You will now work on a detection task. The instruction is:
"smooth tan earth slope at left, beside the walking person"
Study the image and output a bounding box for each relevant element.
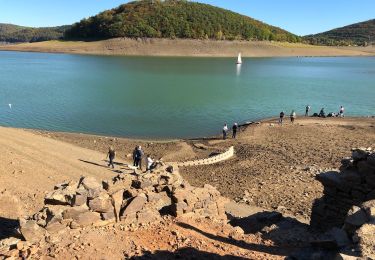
[0,127,129,217]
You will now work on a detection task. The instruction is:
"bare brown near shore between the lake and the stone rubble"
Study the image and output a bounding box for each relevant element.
[0,117,375,220]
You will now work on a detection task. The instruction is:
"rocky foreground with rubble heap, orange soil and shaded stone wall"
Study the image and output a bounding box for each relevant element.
[0,148,375,259]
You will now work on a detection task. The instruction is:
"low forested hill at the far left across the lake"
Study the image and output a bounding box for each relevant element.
[0,23,70,43]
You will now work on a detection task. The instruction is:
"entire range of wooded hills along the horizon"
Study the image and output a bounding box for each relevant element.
[0,0,375,46]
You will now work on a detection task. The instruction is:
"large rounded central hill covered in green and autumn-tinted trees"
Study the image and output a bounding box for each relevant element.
[65,0,300,42]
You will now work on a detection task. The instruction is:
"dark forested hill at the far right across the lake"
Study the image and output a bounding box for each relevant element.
[304,19,375,46]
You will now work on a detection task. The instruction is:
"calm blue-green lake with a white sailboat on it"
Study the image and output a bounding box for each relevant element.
[0,51,375,138]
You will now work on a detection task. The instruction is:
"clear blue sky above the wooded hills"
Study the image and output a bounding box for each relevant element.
[0,0,375,35]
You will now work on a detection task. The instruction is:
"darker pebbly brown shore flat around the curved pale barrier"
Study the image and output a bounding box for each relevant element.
[26,117,375,221]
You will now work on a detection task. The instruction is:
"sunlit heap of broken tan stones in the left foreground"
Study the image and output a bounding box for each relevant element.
[16,167,228,246]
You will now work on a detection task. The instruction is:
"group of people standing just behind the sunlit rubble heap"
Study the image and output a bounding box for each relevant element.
[107,145,161,171]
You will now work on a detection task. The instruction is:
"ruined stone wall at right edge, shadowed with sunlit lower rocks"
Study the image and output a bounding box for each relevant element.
[311,148,375,257]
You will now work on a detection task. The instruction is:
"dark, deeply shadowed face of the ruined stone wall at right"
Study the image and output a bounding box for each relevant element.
[311,149,375,229]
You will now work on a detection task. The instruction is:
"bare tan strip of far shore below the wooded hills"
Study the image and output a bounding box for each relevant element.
[0,38,375,57]
